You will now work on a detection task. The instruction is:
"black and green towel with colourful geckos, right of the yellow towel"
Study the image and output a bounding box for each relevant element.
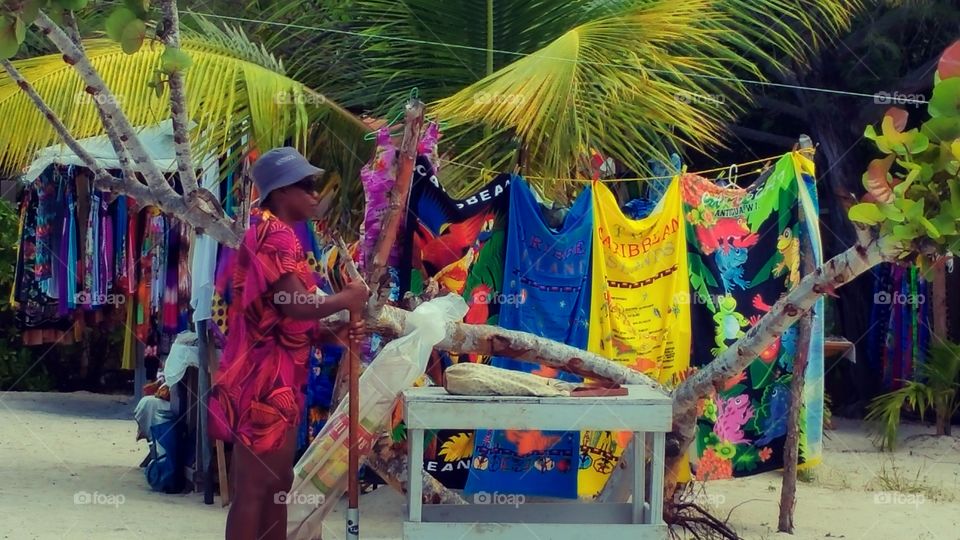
[681,155,807,480]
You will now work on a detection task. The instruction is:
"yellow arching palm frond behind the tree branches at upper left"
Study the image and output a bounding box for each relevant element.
[0,20,366,197]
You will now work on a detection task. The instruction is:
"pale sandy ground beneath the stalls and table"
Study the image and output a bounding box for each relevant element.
[0,392,960,540]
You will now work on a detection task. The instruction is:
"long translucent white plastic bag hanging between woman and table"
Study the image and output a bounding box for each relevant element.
[286,295,467,538]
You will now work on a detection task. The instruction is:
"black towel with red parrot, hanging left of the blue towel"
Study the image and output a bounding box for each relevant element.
[394,159,513,489]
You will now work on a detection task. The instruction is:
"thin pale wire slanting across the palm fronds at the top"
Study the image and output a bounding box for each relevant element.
[183,9,928,105]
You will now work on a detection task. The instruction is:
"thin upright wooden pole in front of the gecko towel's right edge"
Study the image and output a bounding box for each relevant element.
[777,135,818,534]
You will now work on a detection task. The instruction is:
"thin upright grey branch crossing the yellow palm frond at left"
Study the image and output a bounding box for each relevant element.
[163,0,198,195]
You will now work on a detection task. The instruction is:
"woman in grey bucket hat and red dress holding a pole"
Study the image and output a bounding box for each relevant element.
[210,148,368,540]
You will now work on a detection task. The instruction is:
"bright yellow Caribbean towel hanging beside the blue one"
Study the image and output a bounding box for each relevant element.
[578,181,690,499]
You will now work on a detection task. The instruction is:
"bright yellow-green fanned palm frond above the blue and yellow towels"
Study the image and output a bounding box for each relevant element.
[436,0,748,186]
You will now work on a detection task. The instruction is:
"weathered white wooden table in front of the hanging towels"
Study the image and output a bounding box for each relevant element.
[403,386,672,540]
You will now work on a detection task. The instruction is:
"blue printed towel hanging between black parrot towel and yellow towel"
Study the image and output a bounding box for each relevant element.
[466,177,593,499]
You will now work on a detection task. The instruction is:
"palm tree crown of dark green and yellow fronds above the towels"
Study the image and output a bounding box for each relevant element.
[249,0,861,198]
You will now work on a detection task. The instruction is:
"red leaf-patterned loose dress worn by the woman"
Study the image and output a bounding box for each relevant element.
[210,211,319,453]
